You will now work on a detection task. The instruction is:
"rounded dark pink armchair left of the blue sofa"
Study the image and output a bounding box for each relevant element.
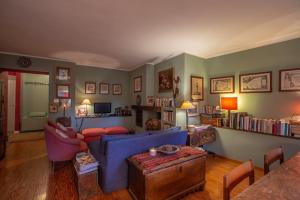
[45,125,88,164]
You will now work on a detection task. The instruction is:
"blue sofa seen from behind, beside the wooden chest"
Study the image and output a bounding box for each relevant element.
[89,130,187,193]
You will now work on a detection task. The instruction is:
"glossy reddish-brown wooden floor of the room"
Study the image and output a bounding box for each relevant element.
[0,133,263,200]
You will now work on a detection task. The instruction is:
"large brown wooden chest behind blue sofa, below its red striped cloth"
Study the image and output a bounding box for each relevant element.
[129,147,206,200]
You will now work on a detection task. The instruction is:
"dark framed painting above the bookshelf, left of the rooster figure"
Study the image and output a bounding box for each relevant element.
[158,68,173,92]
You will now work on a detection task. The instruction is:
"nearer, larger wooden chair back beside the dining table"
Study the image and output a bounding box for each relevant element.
[223,160,254,200]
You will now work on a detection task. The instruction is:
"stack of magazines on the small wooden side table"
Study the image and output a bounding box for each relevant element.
[75,152,99,174]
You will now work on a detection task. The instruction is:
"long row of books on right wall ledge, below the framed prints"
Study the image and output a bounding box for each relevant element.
[229,112,292,136]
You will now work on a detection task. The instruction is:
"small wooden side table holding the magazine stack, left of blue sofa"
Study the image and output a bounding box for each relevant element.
[74,163,99,200]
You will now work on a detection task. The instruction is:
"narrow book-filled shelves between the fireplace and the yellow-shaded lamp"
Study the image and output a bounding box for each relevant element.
[161,107,176,130]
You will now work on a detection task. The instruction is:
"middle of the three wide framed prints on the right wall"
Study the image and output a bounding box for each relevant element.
[239,72,272,93]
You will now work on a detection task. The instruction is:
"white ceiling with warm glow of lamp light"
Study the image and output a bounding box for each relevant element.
[0,0,300,70]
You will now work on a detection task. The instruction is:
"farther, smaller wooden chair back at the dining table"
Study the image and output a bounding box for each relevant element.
[264,147,284,175]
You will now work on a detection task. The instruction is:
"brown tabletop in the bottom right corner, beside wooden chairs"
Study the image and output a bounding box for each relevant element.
[233,152,300,200]
